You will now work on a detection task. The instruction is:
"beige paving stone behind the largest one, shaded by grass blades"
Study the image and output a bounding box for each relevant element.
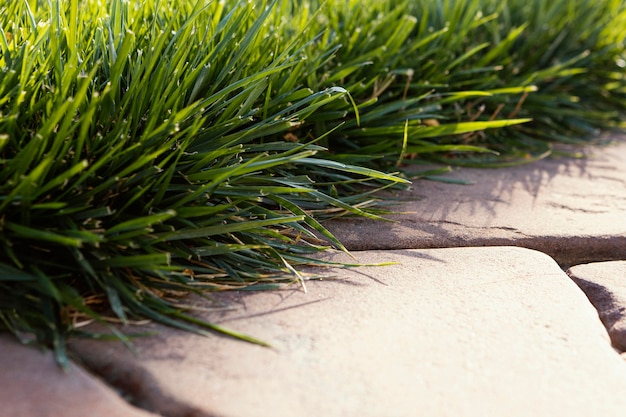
[325,139,626,266]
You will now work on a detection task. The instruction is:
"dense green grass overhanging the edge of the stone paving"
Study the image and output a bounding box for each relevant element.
[0,0,626,362]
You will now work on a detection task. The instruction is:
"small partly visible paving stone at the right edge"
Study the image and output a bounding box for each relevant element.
[567,261,626,351]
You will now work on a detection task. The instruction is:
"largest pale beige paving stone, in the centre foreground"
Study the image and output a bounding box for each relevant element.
[71,247,626,417]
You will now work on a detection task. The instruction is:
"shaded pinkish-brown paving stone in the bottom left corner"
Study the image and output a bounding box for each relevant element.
[0,334,156,417]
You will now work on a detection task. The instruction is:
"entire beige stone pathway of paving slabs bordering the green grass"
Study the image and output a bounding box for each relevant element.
[0,136,626,417]
